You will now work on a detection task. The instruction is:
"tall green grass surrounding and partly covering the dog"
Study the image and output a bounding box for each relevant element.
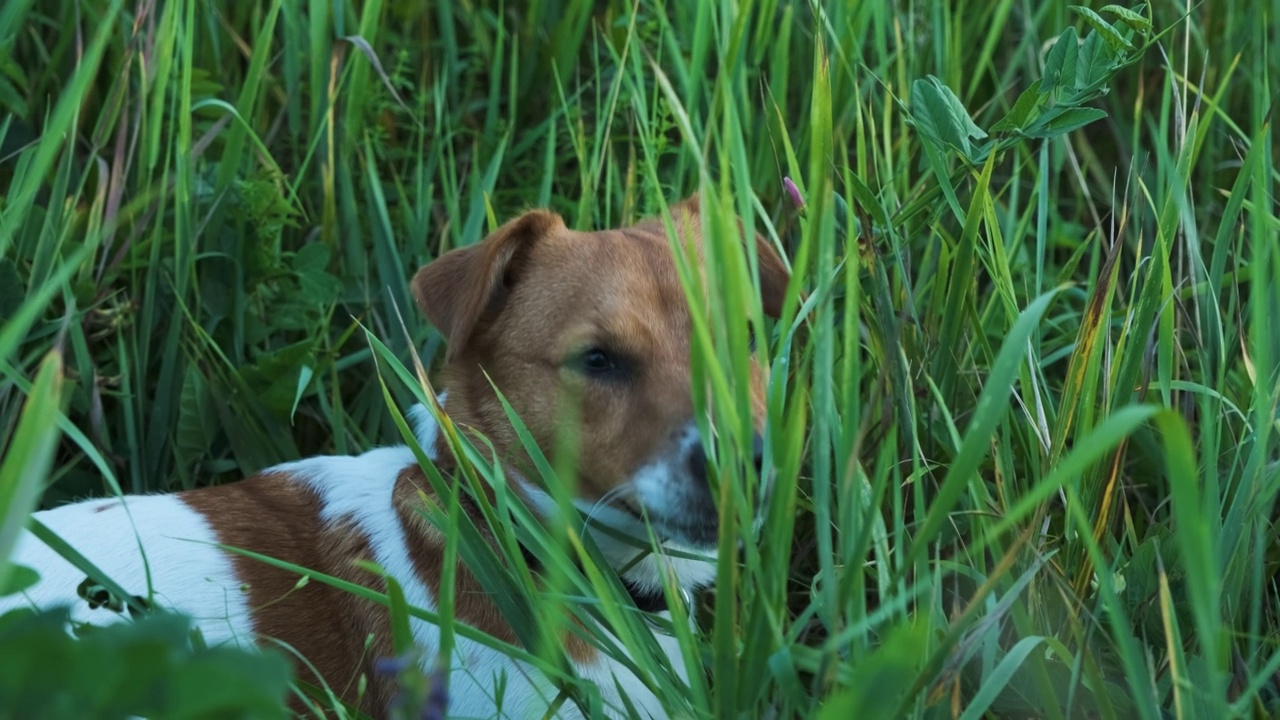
[0,0,1280,719]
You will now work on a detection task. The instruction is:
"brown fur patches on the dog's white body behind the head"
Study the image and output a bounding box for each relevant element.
[180,466,595,716]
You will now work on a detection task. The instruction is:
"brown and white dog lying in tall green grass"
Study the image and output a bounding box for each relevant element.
[0,196,790,717]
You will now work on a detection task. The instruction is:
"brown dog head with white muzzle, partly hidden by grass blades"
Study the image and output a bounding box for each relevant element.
[412,197,788,589]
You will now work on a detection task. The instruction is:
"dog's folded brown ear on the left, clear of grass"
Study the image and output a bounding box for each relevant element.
[411,210,564,360]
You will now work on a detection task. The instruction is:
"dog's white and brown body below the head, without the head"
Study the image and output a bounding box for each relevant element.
[0,407,682,717]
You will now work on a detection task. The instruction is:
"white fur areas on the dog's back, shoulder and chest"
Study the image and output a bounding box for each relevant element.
[0,396,691,719]
